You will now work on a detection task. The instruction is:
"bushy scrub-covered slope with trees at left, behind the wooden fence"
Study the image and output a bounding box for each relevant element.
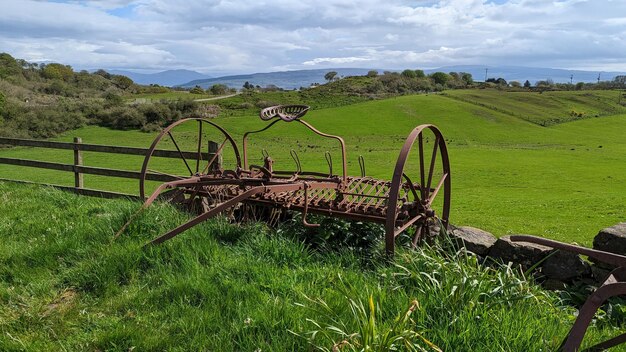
[0,53,205,138]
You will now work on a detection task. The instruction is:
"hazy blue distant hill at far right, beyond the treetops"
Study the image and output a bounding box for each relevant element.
[424,65,626,85]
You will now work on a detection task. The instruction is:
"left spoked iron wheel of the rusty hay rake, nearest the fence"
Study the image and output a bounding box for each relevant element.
[139,118,241,214]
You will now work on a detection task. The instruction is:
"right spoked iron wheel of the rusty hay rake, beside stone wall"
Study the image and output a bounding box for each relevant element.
[385,125,450,255]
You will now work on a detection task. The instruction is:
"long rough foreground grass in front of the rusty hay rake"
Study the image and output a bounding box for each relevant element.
[0,182,618,351]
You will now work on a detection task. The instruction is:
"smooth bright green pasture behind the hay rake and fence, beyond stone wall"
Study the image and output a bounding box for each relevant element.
[0,90,626,245]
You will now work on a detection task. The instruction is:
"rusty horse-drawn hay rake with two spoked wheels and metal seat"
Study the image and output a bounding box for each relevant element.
[124,105,450,254]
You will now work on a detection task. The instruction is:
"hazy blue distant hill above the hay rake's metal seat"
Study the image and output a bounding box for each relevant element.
[180,68,382,89]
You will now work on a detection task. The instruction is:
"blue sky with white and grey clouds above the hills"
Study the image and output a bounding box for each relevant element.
[0,0,626,75]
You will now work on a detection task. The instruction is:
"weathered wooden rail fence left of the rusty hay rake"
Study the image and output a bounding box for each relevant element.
[0,137,211,199]
